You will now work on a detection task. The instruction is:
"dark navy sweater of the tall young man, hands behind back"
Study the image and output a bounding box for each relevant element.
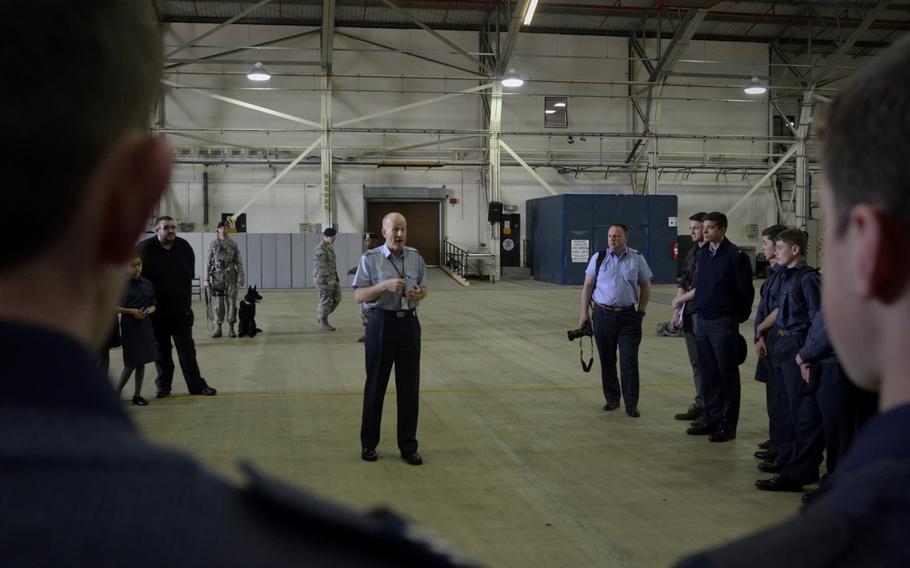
[694,239,755,323]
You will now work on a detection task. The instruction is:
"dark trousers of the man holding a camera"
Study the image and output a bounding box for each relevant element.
[594,306,642,409]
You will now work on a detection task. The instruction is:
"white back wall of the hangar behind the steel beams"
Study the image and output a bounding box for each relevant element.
[160,25,796,255]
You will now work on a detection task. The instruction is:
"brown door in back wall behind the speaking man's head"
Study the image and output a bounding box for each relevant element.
[364,200,442,266]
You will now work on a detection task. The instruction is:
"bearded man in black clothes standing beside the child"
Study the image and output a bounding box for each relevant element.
[142,215,218,398]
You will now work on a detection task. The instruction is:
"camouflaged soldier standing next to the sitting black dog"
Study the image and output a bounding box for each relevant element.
[205,223,244,338]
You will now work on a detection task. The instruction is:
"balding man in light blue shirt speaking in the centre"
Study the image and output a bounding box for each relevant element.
[354,213,427,465]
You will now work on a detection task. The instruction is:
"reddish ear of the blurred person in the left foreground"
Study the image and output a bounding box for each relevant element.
[100,136,171,263]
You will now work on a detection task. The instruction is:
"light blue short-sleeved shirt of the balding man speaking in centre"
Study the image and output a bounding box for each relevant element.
[354,245,427,311]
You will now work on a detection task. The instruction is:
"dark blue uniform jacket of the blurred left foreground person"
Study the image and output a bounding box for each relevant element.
[0,321,478,568]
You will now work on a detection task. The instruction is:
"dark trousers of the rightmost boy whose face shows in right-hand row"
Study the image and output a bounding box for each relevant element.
[774,333,825,484]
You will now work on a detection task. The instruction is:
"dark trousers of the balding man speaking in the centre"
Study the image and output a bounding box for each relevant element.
[360,310,420,453]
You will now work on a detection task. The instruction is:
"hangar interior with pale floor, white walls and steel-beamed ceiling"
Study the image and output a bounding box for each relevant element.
[112,0,910,566]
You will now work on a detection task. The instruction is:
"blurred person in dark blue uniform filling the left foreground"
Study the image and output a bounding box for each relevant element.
[0,0,470,568]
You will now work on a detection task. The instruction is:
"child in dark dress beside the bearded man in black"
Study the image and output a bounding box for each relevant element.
[117,254,158,406]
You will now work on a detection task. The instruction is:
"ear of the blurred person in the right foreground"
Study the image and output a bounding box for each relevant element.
[847,205,910,304]
